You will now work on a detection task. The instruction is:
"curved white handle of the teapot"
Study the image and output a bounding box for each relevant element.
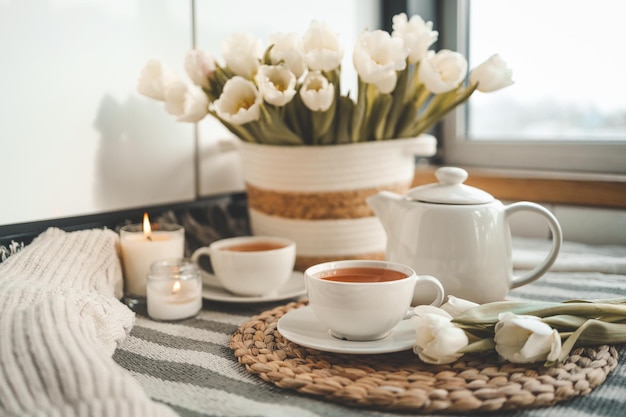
[504,201,563,288]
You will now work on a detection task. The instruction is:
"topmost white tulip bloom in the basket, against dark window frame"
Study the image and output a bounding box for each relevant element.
[391,13,439,63]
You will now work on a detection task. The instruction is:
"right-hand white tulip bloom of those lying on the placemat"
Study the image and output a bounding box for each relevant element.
[494,312,561,363]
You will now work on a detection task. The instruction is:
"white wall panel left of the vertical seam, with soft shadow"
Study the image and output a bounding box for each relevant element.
[0,0,194,225]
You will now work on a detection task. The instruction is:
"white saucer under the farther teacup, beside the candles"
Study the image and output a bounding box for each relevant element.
[200,271,306,303]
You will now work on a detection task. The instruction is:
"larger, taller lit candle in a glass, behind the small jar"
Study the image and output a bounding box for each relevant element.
[120,213,185,300]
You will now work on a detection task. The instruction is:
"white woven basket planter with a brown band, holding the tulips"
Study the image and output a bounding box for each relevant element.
[239,135,436,271]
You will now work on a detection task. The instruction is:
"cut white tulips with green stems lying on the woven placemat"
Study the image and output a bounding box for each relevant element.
[411,296,626,366]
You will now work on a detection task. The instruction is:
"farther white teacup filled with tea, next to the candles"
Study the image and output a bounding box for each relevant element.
[191,236,296,297]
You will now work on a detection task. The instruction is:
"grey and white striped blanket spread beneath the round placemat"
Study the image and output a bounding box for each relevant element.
[113,240,626,417]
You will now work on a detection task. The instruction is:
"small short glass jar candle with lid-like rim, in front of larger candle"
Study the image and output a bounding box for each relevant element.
[146,258,202,321]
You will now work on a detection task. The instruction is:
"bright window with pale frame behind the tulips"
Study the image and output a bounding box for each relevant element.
[435,0,626,173]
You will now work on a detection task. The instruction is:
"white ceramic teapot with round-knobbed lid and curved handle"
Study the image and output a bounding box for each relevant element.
[367,167,563,305]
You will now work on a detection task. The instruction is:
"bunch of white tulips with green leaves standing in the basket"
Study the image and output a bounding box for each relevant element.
[138,14,513,145]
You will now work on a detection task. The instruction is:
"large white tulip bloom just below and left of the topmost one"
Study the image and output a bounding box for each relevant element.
[352,30,408,94]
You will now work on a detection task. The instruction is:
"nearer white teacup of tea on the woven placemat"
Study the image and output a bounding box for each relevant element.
[304,260,444,341]
